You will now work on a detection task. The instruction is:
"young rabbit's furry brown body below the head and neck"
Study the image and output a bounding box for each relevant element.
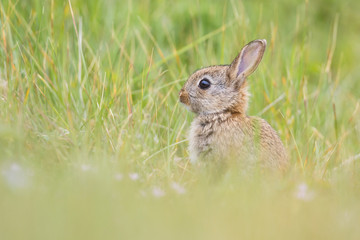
[189,113,288,169]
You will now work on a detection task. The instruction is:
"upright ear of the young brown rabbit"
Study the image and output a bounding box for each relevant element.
[228,39,266,83]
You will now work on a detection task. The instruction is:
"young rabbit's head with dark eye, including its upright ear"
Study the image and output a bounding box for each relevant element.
[179,40,266,114]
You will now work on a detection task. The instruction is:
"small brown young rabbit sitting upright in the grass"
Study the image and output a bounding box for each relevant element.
[179,40,288,170]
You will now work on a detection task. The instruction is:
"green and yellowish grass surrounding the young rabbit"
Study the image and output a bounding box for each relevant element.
[0,0,360,240]
